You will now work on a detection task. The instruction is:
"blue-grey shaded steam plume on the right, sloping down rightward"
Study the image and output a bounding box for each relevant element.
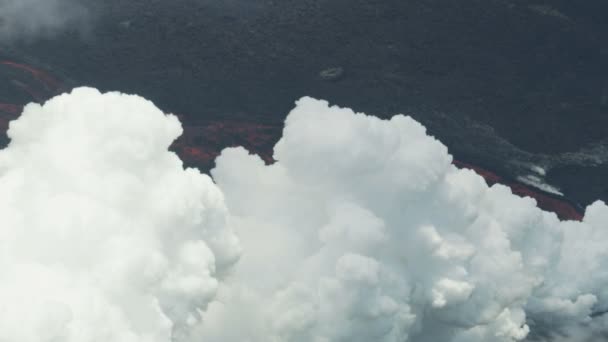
[204,98,608,342]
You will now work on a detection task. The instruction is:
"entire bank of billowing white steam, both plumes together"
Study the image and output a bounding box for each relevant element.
[0,89,608,342]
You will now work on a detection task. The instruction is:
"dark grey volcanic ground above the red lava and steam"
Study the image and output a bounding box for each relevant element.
[0,0,608,205]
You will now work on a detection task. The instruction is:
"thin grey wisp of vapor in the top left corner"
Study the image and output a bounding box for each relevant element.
[0,0,90,42]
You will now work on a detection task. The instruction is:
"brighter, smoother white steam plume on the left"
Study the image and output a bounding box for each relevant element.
[0,89,240,342]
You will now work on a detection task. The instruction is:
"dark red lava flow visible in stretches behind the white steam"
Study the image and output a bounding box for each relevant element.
[0,60,582,220]
